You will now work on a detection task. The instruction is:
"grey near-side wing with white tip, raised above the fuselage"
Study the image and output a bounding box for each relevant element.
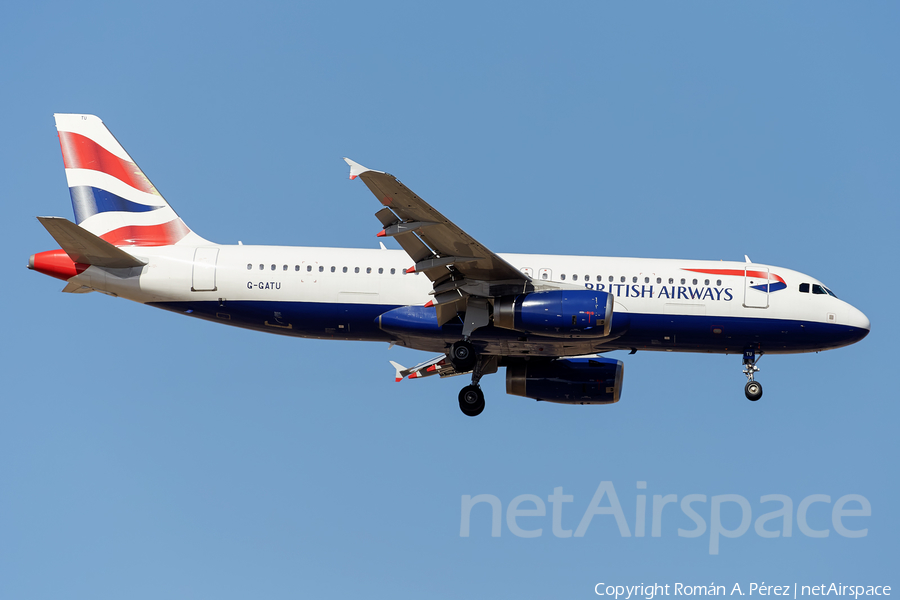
[344,158,534,327]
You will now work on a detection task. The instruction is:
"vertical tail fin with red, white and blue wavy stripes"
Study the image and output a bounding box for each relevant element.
[54,114,205,246]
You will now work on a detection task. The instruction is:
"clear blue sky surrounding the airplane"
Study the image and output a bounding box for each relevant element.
[0,1,900,599]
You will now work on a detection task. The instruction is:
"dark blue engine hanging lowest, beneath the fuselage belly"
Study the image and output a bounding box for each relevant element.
[506,357,625,404]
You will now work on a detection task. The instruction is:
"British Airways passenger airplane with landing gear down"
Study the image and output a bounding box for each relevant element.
[28,114,870,416]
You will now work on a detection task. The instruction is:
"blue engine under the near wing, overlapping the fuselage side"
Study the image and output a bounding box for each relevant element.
[494,290,614,338]
